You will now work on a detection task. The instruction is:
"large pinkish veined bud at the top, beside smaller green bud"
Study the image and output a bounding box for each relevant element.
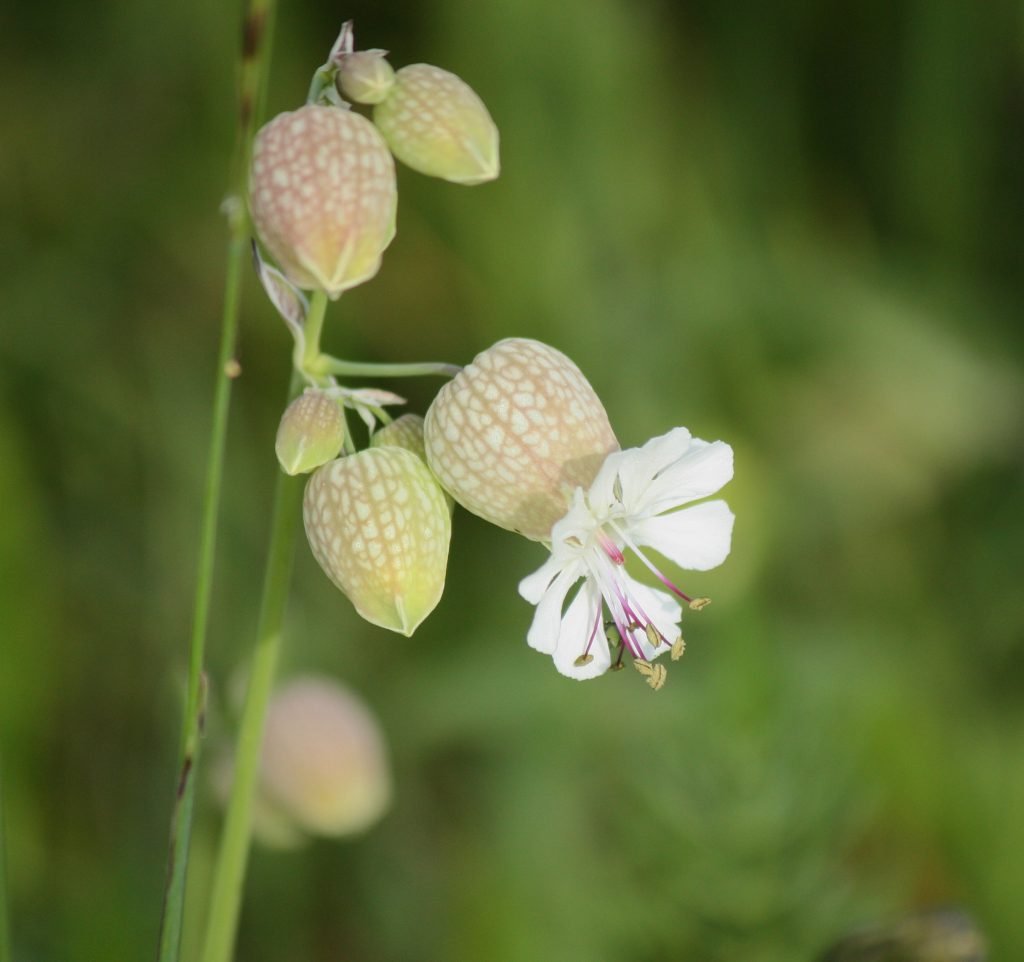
[249,104,398,297]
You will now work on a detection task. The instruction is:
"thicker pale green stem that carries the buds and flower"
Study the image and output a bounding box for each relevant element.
[202,292,327,962]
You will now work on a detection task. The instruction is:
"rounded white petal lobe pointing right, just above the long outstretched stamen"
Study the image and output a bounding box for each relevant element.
[629,501,735,572]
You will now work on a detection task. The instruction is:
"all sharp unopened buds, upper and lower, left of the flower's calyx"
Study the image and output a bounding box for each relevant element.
[249,24,500,635]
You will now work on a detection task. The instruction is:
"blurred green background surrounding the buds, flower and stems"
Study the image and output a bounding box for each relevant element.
[0,0,1024,962]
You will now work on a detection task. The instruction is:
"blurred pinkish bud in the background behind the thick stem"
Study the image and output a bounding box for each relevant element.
[213,675,391,847]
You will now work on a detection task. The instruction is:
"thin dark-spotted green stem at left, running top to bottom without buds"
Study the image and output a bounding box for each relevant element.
[159,0,275,962]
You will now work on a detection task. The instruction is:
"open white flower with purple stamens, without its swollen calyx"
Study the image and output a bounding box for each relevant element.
[519,427,734,687]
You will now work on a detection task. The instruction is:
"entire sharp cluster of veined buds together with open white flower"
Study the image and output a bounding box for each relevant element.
[250,25,733,691]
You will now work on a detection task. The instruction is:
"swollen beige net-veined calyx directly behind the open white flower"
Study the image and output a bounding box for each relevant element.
[424,338,618,541]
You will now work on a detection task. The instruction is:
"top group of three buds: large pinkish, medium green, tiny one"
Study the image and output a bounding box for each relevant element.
[249,24,501,298]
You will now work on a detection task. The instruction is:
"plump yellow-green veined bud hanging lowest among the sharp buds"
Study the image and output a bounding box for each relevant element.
[302,446,452,635]
